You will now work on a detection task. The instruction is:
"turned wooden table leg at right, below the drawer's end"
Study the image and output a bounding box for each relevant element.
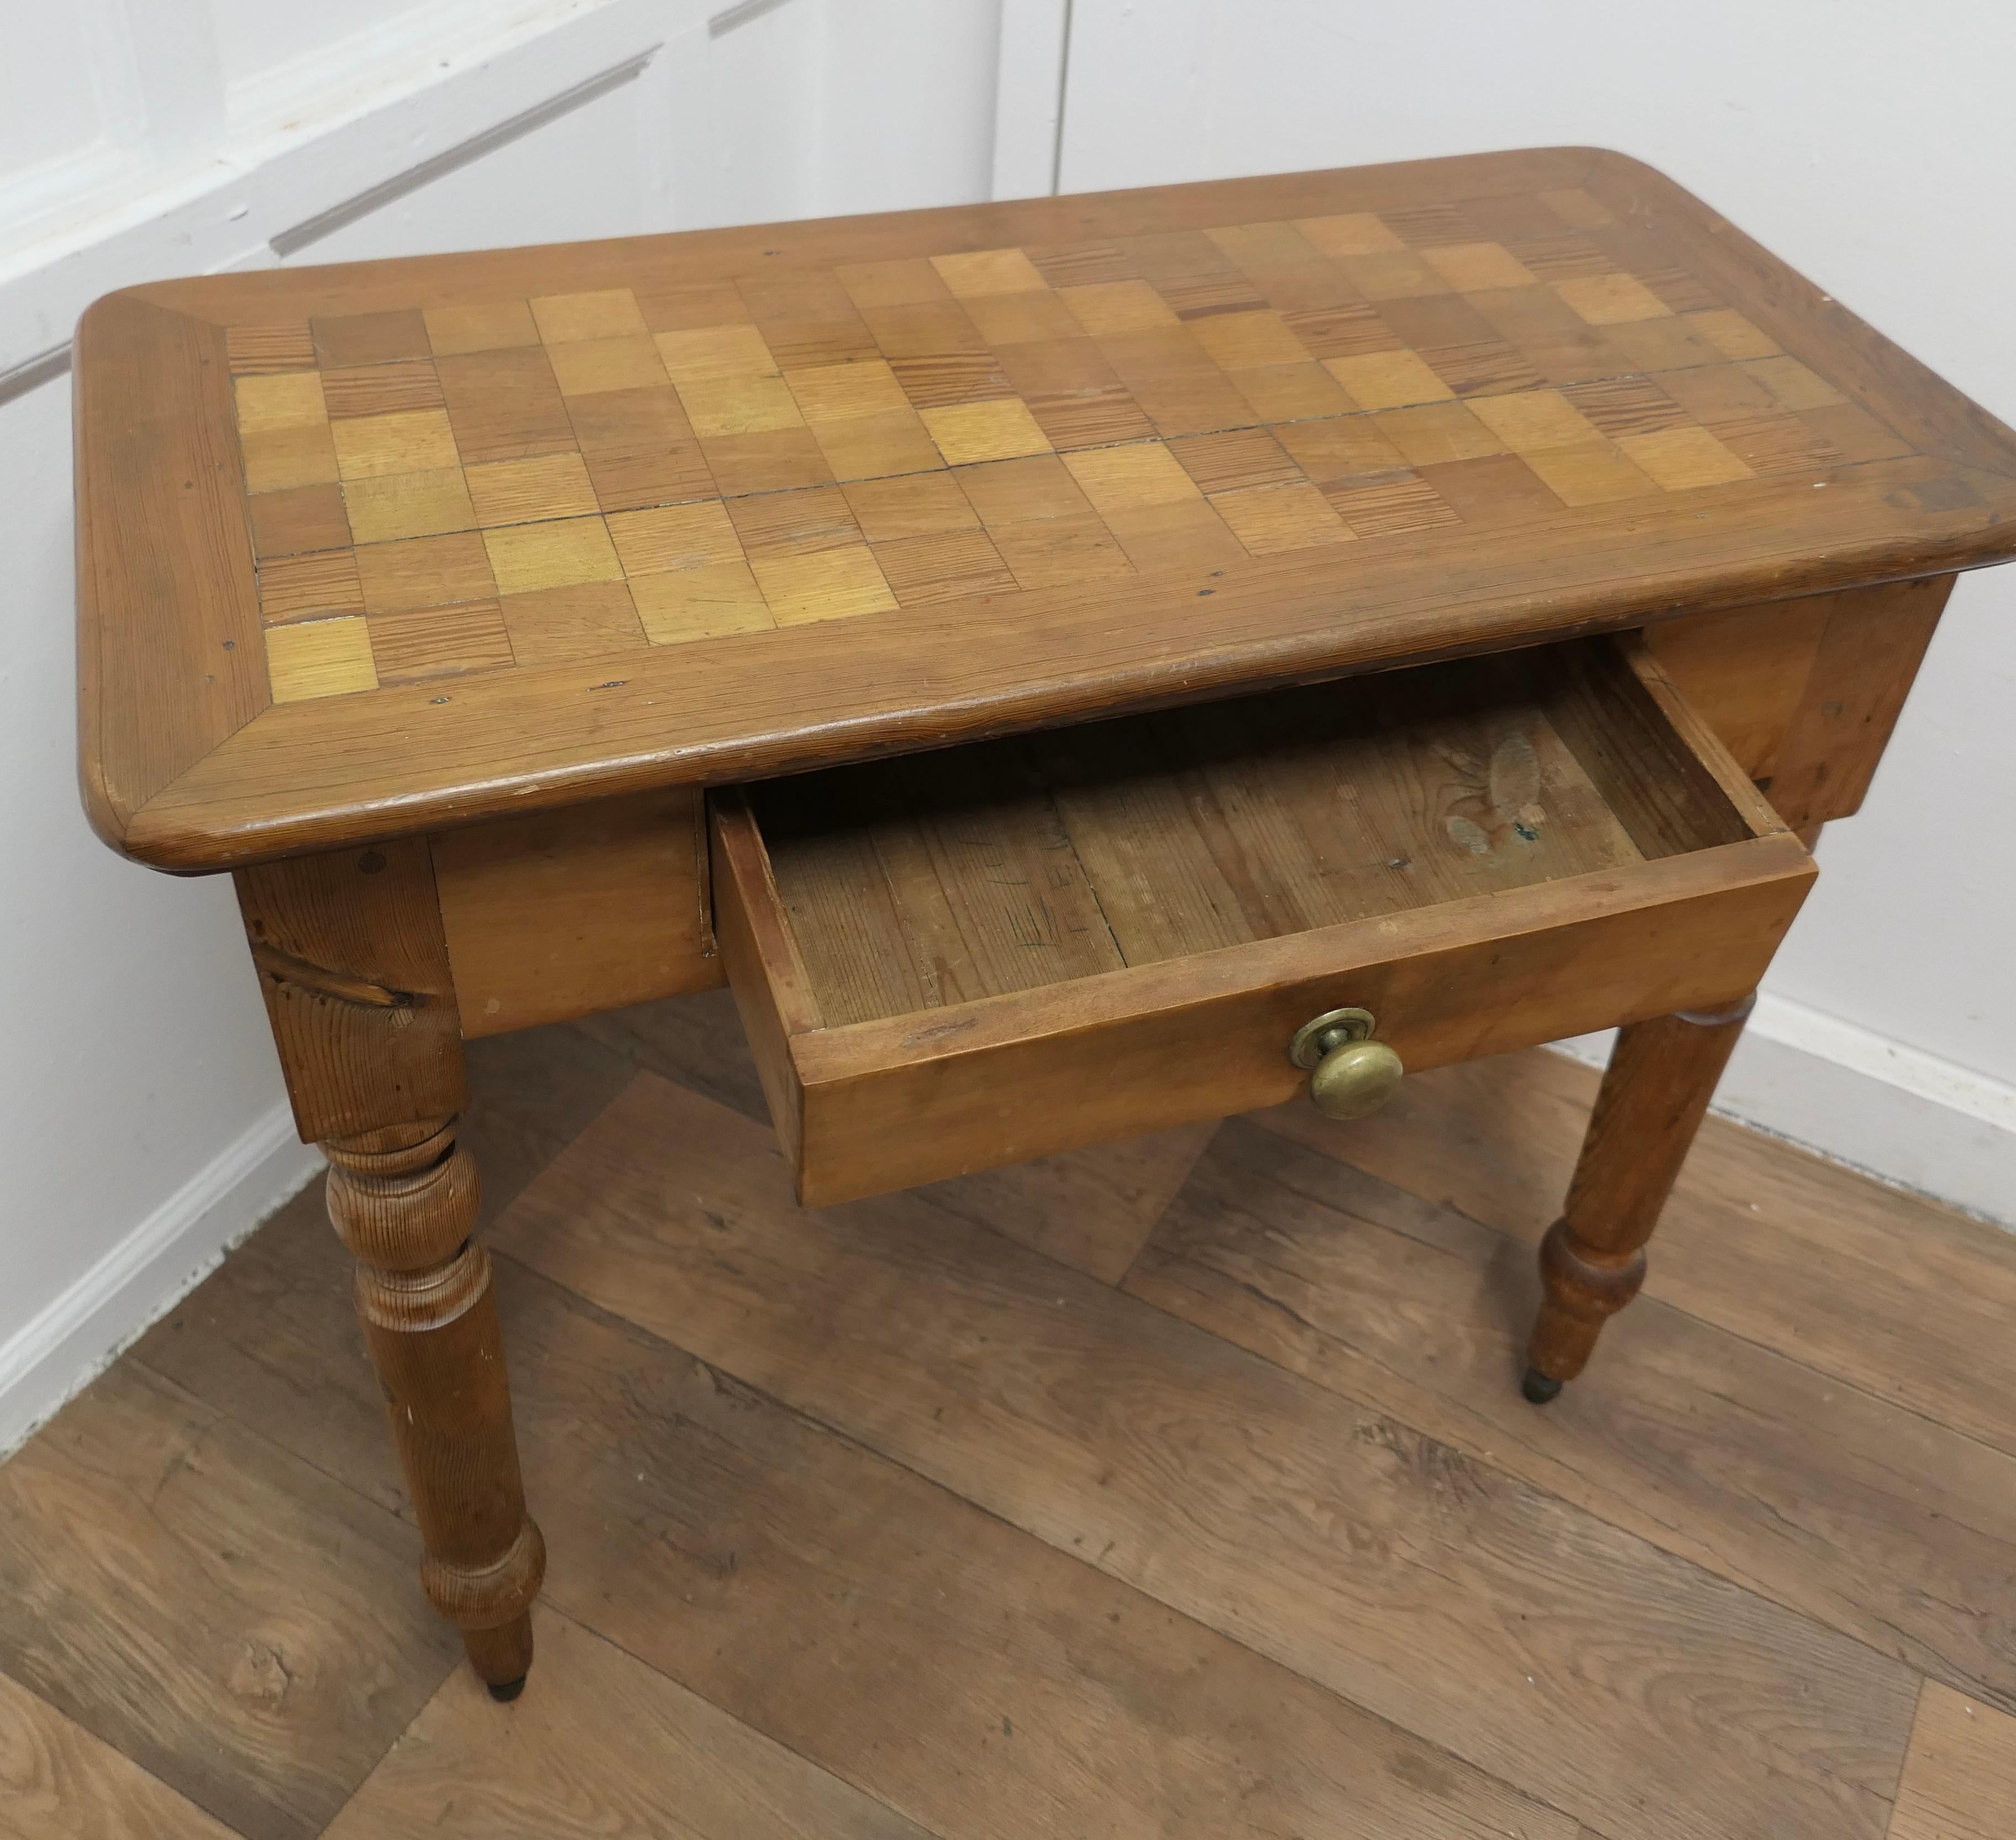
[1522,997,1754,1405]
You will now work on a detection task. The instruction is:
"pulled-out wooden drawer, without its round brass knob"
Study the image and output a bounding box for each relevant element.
[712,639,1814,1205]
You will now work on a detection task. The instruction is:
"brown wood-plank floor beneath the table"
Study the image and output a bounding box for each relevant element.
[0,996,2016,1840]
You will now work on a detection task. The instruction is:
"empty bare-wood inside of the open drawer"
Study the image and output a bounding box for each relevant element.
[750,643,1752,1028]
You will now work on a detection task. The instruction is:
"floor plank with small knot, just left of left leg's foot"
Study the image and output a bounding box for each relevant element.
[0,1360,461,1840]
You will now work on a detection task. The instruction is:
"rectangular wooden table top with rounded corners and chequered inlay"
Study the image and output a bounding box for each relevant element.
[77,149,2016,869]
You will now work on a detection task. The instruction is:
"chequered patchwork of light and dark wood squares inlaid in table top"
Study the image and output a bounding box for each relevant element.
[228,191,1911,701]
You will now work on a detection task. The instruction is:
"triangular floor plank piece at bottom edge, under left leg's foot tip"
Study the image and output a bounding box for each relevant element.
[329,1608,930,1840]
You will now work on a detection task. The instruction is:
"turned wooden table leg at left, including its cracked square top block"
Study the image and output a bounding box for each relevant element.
[236,840,547,1699]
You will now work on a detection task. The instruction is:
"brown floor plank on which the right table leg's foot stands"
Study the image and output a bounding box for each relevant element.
[1125,1121,2016,1709]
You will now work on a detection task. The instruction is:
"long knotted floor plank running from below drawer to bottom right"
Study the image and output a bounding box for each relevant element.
[492,1078,1917,1840]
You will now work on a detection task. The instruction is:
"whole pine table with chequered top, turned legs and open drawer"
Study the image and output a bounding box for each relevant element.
[77,149,2016,1697]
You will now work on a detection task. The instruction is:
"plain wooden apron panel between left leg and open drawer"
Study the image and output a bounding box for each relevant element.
[429,788,722,1038]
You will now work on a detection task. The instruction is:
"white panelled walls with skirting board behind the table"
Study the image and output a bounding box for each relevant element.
[0,0,2016,1451]
